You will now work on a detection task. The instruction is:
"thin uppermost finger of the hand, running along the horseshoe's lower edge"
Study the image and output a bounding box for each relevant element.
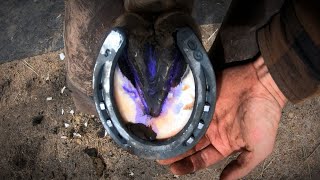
[157,136,210,165]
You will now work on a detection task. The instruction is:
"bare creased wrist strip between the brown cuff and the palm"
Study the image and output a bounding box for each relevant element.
[252,56,288,108]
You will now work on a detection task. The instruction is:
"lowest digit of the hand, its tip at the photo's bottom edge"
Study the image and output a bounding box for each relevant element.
[220,151,264,180]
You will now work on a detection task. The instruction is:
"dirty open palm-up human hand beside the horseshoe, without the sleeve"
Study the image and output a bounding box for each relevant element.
[158,57,287,179]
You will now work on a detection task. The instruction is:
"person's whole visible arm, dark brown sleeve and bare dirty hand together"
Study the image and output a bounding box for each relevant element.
[159,0,320,179]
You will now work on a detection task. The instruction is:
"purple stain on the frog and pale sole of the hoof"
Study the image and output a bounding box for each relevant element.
[121,44,185,122]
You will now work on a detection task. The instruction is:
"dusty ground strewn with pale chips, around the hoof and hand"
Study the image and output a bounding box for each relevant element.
[0,0,320,180]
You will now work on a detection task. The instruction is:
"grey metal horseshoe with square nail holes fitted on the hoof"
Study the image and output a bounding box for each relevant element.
[93,28,216,159]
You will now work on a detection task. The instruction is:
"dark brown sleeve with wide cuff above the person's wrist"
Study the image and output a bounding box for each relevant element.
[258,0,320,102]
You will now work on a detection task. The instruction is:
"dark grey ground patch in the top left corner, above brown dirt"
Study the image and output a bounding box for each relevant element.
[0,0,64,63]
